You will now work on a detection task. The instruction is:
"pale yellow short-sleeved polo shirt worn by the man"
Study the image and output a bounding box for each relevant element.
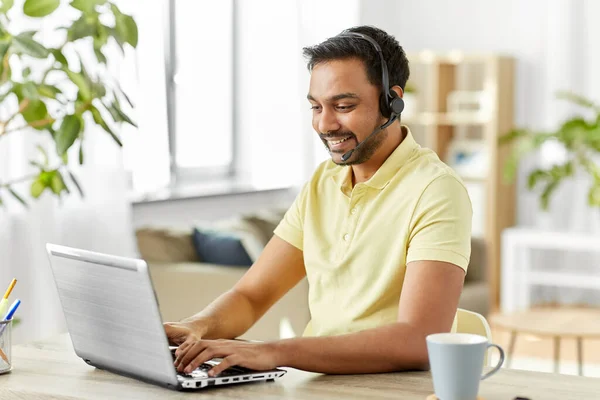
[275,127,472,336]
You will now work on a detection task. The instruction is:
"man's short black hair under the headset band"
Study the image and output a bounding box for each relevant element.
[302,25,410,90]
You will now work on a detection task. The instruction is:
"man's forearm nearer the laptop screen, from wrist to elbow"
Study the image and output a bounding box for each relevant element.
[182,289,256,339]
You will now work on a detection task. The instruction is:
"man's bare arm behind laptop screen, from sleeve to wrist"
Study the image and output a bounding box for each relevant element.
[173,236,306,339]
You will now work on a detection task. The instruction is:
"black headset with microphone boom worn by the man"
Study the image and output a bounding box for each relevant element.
[337,31,404,162]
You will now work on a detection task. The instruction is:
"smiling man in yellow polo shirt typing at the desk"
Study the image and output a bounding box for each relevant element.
[165,26,472,376]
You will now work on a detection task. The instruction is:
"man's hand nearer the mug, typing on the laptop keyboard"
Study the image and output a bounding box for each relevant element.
[174,340,279,376]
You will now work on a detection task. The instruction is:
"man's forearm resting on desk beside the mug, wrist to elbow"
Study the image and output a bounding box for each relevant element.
[272,323,428,374]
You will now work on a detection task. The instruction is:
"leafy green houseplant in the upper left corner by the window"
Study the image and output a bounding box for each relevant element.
[0,0,138,206]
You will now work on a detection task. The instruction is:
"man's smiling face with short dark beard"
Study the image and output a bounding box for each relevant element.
[307,59,387,165]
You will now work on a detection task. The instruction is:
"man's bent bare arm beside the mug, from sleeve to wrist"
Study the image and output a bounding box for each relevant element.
[276,261,465,374]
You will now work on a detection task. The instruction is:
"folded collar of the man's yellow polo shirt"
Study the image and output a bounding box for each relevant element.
[333,125,419,194]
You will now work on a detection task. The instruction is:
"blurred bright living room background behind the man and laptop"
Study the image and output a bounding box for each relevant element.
[0,0,600,376]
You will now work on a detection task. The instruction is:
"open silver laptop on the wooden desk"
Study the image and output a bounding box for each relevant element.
[46,244,286,390]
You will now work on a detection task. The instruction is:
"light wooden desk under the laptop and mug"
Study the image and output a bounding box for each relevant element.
[0,335,600,400]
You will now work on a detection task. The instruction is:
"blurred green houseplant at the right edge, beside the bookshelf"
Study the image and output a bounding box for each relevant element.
[500,91,600,210]
